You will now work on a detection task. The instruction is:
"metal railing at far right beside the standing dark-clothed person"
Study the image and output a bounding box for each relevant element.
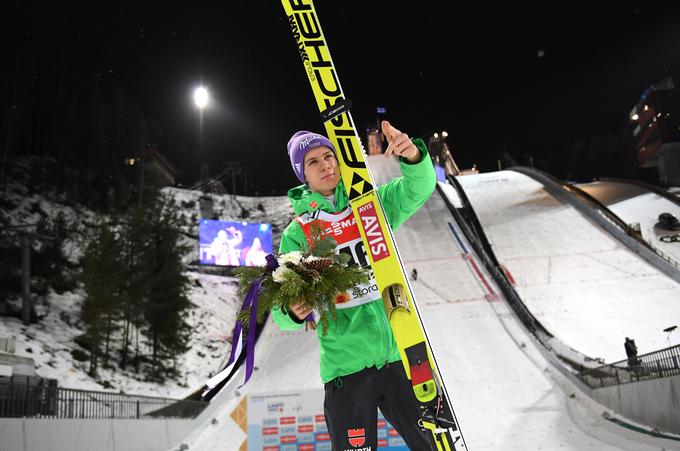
[579,345,680,388]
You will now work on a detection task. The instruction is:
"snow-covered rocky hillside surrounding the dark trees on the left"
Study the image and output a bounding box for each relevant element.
[0,162,293,398]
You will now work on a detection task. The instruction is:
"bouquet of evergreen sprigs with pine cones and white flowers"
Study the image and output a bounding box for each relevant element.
[236,224,370,335]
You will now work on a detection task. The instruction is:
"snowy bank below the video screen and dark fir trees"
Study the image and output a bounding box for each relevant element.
[0,272,240,398]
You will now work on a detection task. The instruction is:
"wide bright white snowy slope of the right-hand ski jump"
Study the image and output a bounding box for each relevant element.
[458,171,680,362]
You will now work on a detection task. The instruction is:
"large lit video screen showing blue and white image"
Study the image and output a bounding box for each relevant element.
[198,219,272,266]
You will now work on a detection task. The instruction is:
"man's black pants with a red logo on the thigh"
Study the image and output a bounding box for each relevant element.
[324,362,431,451]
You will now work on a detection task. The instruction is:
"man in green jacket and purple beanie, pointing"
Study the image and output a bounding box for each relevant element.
[272,121,436,450]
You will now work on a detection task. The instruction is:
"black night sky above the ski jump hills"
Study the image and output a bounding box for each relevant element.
[2,1,680,194]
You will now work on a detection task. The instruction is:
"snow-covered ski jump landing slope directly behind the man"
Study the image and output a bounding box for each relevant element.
[175,157,680,451]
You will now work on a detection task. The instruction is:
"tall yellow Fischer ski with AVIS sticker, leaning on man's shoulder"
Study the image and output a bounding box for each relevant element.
[281,0,467,451]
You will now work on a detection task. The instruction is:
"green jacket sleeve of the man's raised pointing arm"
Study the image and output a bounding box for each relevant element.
[378,138,437,230]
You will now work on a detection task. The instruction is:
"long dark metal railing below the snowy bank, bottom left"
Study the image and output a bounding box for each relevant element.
[0,376,208,419]
